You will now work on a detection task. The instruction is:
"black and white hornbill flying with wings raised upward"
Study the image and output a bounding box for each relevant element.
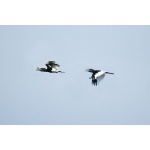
[36,61,64,73]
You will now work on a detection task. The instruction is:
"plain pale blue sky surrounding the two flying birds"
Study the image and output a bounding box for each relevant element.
[0,26,150,125]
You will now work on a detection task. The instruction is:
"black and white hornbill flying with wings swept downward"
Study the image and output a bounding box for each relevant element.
[85,69,114,86]
